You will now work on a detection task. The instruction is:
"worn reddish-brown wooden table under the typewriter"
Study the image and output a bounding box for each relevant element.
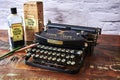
[0,30,120,80]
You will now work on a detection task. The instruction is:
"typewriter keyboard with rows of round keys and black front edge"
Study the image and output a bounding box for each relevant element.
[26,44,84,72]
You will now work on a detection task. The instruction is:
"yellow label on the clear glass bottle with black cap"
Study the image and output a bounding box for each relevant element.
[10,23,23,41]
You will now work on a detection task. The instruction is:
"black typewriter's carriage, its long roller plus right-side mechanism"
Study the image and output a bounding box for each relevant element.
[46,20,101,56]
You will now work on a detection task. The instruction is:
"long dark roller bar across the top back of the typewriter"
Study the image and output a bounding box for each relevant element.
[47,22,101,34]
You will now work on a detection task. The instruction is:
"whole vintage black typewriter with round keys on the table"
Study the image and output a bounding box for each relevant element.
[25,22,101,74]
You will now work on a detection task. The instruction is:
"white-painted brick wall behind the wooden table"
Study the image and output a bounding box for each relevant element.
[0,0,120,35]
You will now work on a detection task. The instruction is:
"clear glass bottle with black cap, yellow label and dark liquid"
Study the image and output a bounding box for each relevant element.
[7,8,25,50]
